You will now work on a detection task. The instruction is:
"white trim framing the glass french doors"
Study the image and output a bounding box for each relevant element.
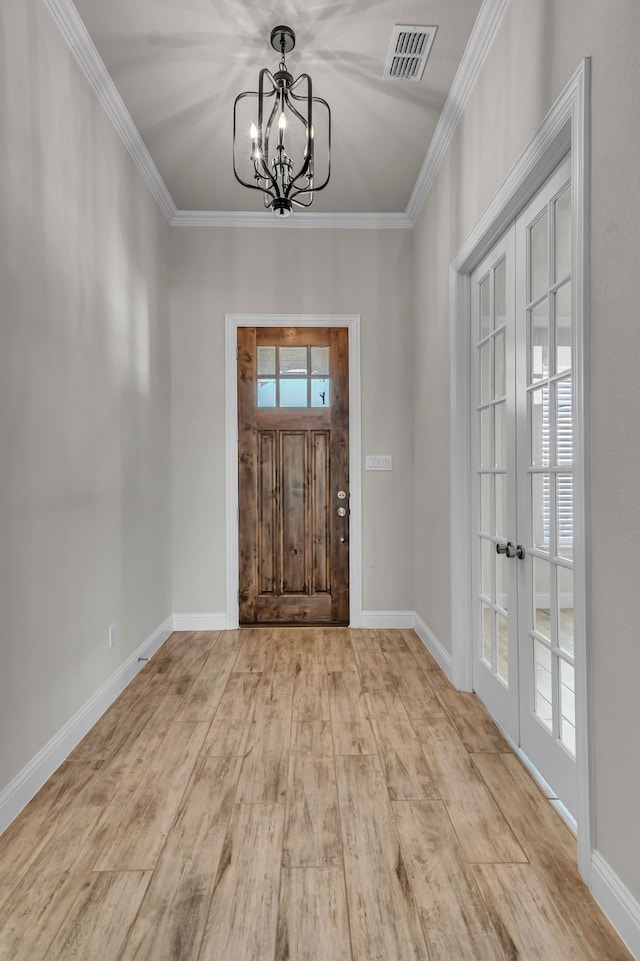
[449,59,594,883]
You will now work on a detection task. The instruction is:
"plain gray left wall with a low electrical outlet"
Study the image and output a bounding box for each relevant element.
[0,0,171,790]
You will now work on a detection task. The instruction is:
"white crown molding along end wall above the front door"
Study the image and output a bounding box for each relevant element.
[170,210,413,230]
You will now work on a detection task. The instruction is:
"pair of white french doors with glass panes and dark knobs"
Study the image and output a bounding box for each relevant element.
[471,157,576,814]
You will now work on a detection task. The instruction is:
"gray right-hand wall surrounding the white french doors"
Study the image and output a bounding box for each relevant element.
[414,0,640,898]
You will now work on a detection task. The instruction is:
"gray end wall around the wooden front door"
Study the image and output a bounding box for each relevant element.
[171,225,413,613]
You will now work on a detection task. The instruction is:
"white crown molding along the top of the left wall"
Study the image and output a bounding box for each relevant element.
[44,0,177,223]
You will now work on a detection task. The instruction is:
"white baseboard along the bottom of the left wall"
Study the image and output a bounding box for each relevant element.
[0,617,173,833]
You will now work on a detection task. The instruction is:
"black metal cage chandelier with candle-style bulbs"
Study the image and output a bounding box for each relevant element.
[233,26,331,217]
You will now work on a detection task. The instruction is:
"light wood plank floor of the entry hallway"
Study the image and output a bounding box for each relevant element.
[0,628,631,961]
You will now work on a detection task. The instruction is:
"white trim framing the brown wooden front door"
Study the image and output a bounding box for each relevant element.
[225,314,362,629]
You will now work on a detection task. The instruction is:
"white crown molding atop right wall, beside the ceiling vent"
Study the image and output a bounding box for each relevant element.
[406,0,509,226]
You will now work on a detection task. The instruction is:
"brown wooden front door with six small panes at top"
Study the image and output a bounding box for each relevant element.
[238,327,349,624]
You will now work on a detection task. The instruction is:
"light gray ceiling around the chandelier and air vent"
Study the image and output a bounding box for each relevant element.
[66,0,482,216]
